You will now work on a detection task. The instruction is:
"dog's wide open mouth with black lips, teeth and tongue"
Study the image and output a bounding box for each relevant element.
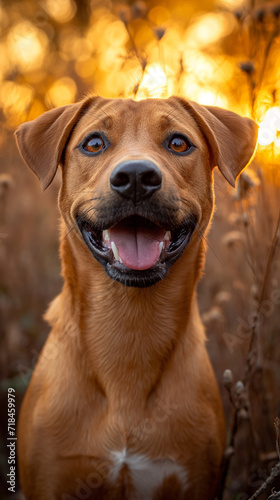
[78,215,196,287]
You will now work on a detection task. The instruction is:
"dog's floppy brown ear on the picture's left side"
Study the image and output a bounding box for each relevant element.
[15,97,93,190]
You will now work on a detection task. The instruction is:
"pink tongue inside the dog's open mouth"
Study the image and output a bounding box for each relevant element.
[109,219,165,271]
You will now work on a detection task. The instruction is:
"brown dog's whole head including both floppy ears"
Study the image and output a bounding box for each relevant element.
[16,97,257,287]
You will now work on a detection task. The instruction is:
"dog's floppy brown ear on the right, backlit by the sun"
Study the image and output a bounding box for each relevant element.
[177,99,258,187]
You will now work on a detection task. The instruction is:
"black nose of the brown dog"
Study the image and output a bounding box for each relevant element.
[110,160,162,203]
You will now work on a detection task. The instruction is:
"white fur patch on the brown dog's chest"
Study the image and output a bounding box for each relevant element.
[109,448,187,500]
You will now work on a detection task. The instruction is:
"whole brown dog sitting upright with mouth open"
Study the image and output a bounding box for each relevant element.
[14,97,257,500]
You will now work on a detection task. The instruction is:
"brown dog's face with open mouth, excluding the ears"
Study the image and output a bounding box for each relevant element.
[60,100,212,286]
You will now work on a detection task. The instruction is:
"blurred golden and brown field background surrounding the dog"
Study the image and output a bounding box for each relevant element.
[0,0,280,500]
